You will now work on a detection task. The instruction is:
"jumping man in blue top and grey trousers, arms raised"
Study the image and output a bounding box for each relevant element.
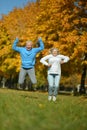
[12,38,44,89]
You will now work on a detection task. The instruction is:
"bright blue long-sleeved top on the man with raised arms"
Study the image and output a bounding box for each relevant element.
[12,38,44,68]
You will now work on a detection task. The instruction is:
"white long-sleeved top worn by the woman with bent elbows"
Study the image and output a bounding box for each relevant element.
[40,54,69,74]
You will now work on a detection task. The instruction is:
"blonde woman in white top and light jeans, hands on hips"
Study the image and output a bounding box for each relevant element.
[40,48,69,101]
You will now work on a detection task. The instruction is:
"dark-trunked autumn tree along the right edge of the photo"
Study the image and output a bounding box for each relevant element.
[75,0,87,94]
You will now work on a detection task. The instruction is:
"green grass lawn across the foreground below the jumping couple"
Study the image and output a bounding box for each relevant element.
[0,89,87,130]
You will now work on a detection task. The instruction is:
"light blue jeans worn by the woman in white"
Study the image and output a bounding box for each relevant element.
[48,74,61,96]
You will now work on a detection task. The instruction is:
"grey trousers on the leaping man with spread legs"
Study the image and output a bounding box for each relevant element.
[18,68,37,84]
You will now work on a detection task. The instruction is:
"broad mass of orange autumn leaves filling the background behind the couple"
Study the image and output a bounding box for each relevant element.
[0,0,87,77]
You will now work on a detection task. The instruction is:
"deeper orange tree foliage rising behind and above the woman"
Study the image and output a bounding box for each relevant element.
[33,0,87,83]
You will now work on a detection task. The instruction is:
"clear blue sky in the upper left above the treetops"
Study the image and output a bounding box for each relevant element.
[0,0,36,18]
